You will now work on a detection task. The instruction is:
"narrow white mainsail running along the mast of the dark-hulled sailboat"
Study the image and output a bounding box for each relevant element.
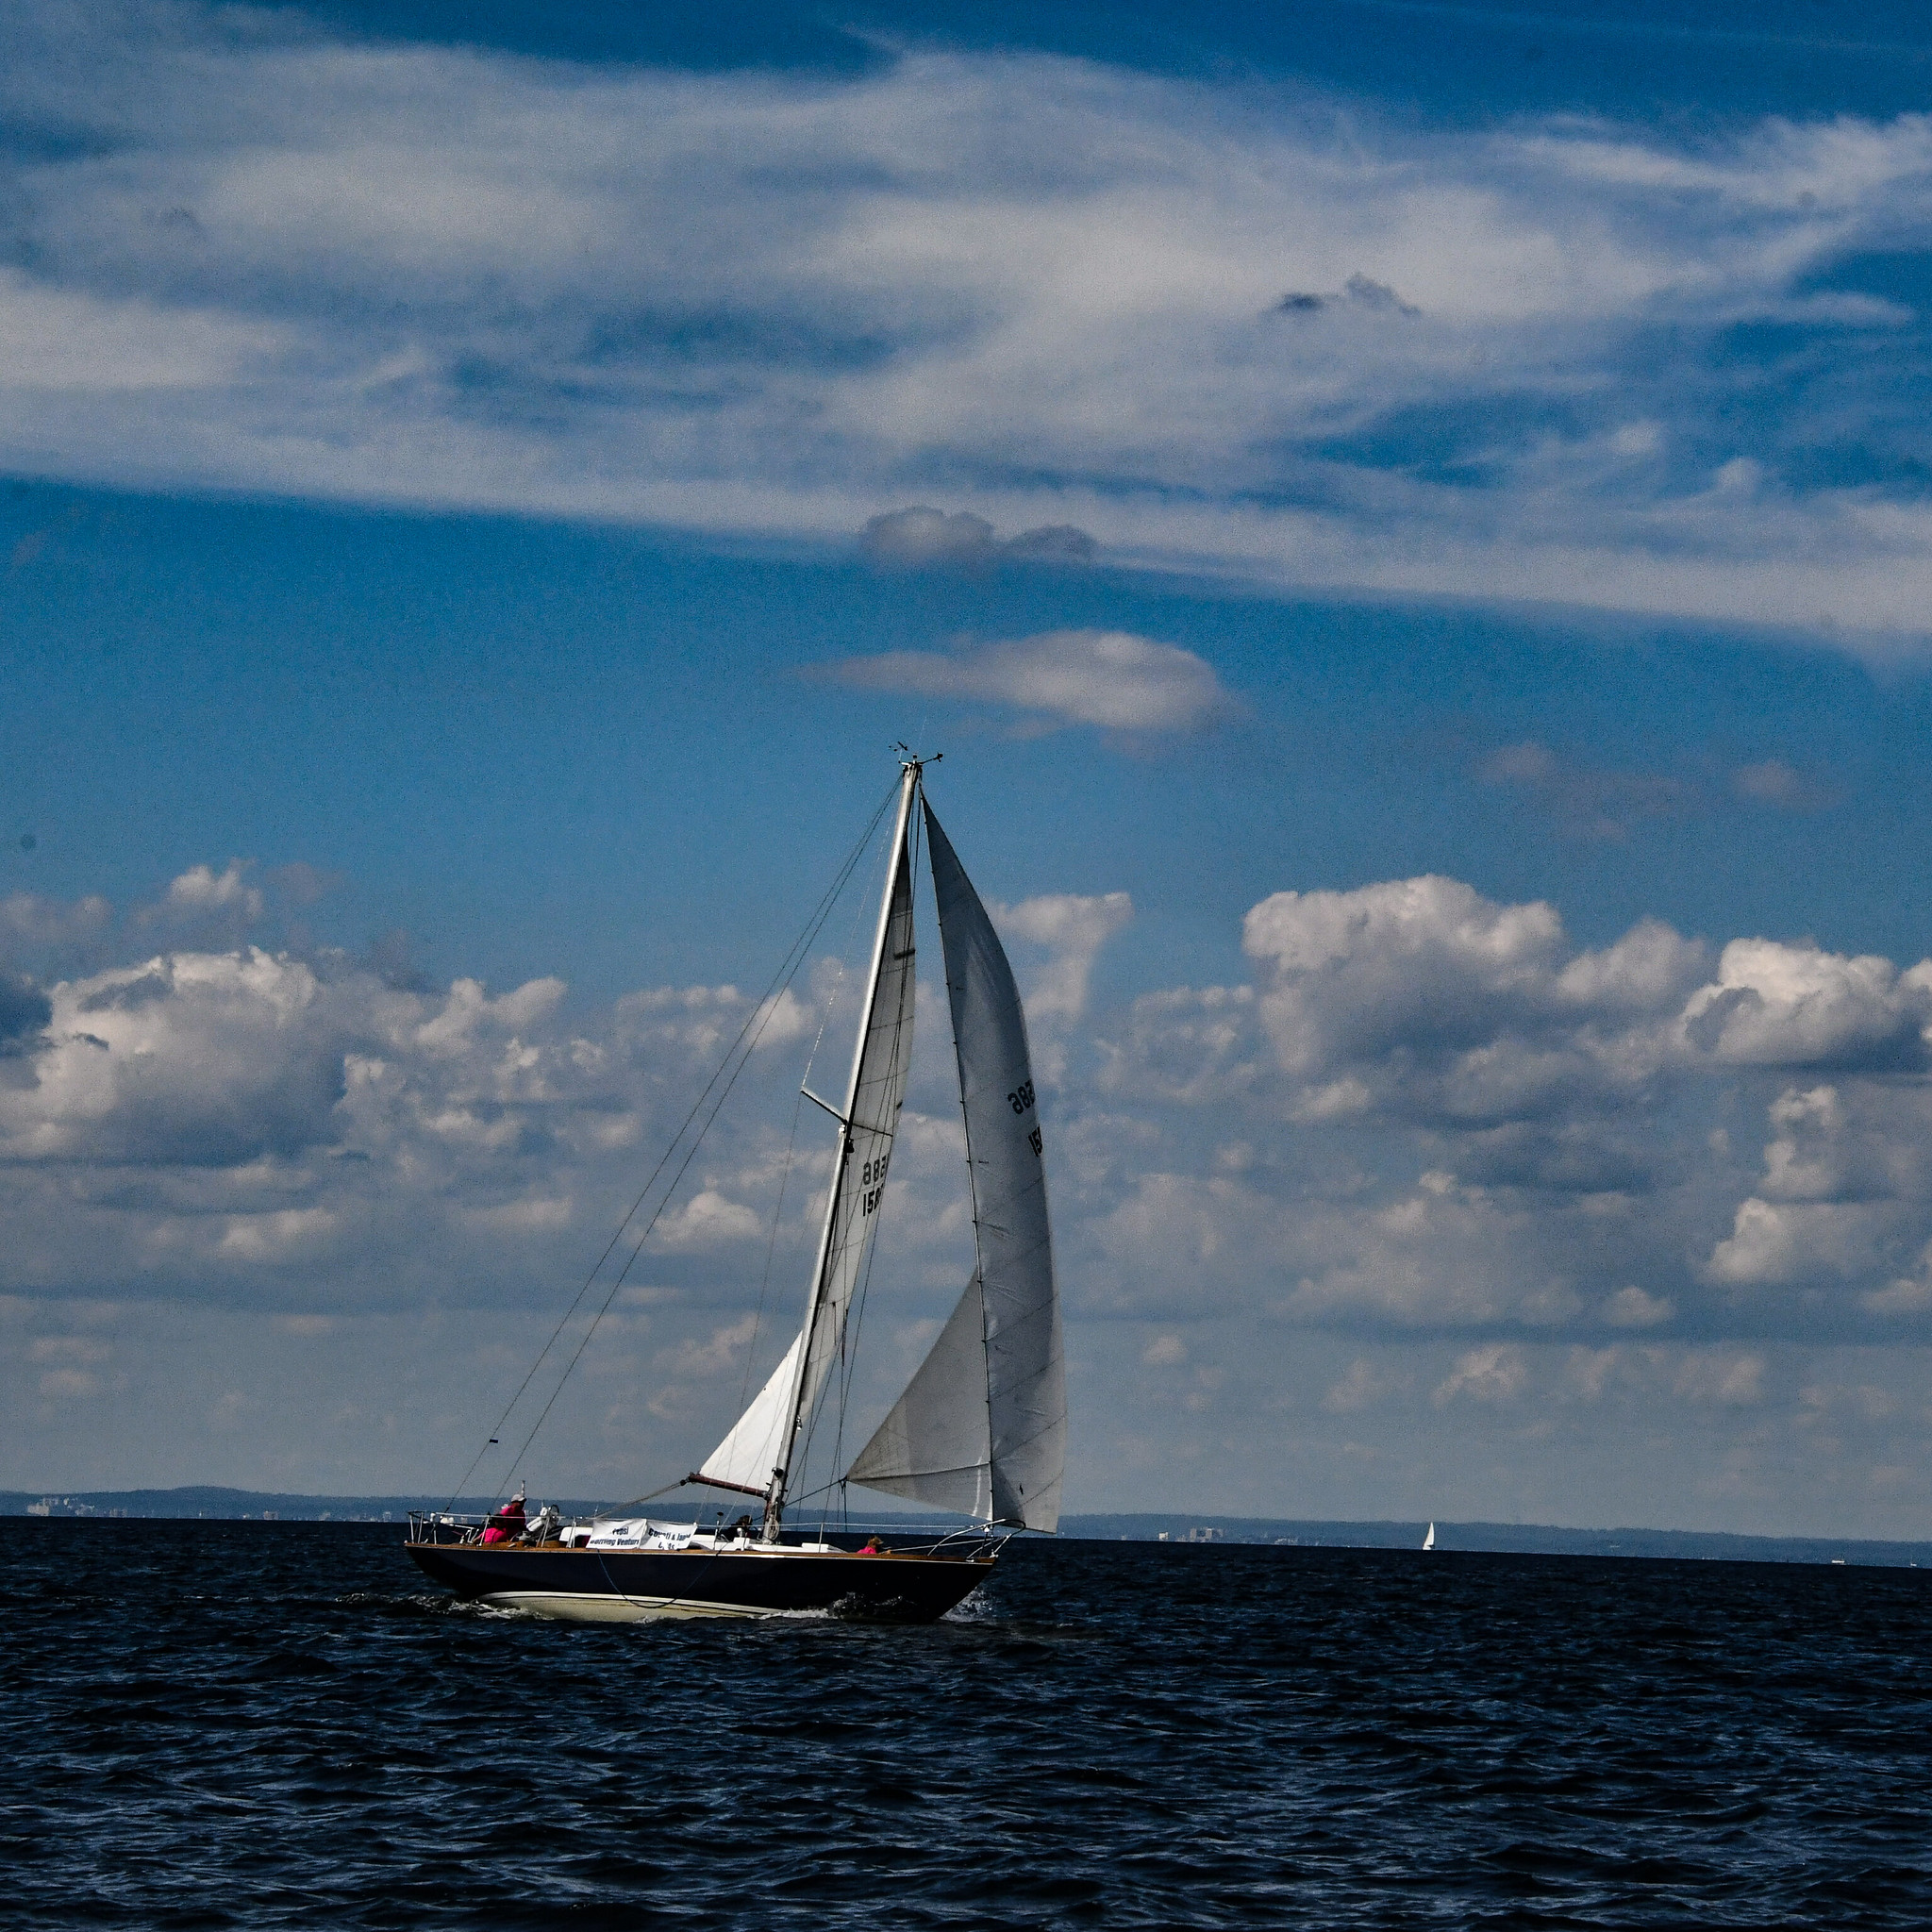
[697,789,914,1491]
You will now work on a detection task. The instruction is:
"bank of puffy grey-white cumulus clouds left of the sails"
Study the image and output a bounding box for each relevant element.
[0,908,876,1312]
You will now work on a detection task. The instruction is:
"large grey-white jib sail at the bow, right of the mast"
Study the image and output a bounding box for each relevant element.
[848,806,1066,1530]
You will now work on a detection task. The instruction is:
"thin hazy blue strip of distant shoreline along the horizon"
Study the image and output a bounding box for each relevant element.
[0,1486,1932,1569]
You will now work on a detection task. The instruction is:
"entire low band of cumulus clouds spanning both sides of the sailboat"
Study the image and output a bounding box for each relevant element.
[11,846,1932,1515]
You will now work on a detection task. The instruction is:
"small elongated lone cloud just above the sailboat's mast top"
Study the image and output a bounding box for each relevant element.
[829,630,1235,734]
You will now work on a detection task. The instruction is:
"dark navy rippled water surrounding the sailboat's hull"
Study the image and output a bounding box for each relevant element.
[15,1521,1932,1928]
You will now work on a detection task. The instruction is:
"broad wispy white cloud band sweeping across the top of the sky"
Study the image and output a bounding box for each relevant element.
[11,4,1932,651]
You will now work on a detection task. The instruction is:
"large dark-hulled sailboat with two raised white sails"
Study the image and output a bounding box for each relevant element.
[408,754,1066,1623]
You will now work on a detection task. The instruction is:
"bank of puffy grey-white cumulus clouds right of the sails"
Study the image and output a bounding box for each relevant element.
[1078,877,1932,1333]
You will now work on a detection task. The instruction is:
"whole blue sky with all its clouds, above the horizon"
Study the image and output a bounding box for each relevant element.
[0,0,1932,1536]
